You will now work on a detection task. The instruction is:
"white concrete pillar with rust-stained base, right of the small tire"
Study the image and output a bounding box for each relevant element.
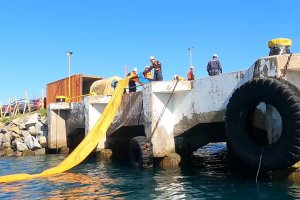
[143,81,191,157]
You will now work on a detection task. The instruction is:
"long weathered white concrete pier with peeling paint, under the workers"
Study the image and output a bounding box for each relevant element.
[46,54,300,161]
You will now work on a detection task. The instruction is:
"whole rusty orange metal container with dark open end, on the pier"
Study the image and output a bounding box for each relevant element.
[46,74,102,106]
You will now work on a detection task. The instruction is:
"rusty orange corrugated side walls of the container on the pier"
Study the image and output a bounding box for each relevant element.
[46,74,82,105]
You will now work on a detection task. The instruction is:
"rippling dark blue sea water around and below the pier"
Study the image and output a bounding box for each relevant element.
[0,144,300,200]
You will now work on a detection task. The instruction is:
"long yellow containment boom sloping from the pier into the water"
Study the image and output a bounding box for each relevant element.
[0,77,130,183]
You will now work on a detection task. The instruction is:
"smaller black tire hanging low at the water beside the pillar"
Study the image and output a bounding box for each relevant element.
[129,136,153,168]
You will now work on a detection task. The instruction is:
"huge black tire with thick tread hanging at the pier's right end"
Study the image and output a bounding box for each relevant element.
[225,78,300,171]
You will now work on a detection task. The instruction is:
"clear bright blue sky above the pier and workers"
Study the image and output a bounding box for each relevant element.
[0,0,300,104]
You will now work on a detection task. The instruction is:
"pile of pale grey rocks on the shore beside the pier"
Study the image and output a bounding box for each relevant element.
[0,113,48,157]
